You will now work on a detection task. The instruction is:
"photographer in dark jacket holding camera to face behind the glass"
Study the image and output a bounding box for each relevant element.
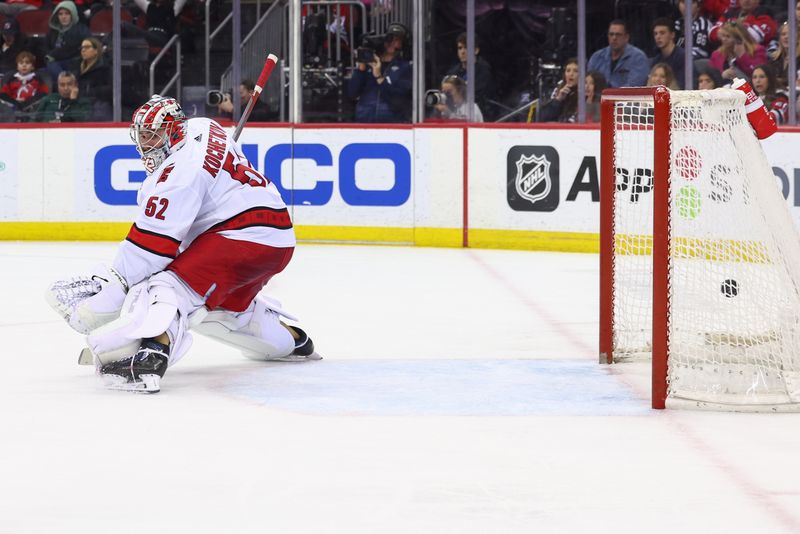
[347,23,411,123]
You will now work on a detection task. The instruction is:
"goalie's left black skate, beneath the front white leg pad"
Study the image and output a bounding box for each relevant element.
[99,339,169,393]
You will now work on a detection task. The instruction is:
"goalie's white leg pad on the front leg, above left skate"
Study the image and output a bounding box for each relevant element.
[87,281,185,364]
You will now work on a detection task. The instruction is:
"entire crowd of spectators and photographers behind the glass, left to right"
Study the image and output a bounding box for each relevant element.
[0,0,800,123]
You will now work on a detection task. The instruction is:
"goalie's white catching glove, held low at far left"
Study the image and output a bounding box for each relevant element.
[45,265,128,334]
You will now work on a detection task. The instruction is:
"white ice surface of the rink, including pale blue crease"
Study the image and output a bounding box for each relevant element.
[0,242,800,534]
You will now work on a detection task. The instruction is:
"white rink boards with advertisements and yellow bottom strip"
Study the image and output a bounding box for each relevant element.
[0,124,800,252]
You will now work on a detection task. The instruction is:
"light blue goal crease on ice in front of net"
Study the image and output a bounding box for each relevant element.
[225,360,649,416]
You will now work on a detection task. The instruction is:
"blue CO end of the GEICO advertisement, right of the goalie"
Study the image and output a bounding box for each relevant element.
[276,129,414,228]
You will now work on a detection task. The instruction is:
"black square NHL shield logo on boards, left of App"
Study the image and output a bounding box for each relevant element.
[507,146,559,215]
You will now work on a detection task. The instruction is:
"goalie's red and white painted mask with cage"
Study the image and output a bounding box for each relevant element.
[130,95,186,174]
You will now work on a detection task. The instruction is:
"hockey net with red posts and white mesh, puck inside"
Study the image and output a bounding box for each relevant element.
[600,88,800,411]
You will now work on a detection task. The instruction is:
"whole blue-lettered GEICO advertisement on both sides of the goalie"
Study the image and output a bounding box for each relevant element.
[76,128,413,227]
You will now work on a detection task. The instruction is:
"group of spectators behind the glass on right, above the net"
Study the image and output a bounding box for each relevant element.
[539,0,800,124]
